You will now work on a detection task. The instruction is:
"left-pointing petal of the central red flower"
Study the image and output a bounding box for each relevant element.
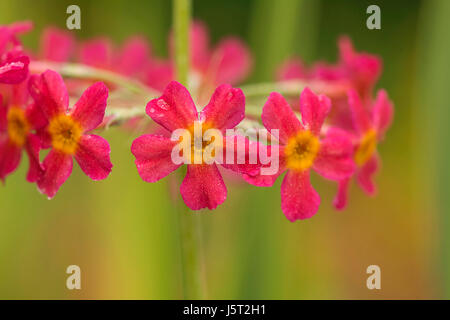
[131,134,181,182]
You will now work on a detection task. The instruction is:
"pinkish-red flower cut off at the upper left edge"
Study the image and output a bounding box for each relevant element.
[0,22,32,84]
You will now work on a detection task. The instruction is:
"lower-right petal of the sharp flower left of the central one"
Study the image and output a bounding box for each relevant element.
[75,135,112,181]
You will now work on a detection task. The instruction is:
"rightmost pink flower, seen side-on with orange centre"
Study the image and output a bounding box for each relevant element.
[334,90,394,209]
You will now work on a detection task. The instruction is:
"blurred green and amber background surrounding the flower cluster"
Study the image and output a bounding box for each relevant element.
[0,0,450,299]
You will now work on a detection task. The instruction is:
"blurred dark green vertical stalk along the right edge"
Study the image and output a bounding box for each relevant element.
[412,0,450,299]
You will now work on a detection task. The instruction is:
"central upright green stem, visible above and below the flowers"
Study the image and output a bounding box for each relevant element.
[173,0,205,299]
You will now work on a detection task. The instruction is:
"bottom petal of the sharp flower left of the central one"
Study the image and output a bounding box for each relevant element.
[37,150,73,199]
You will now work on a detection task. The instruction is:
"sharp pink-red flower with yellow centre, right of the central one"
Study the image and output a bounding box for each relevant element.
[244,88,355,222]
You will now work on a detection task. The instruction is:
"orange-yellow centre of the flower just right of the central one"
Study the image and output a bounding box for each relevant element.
[284,131,320,171]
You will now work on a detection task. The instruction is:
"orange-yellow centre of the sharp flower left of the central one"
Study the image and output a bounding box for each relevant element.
[48,114,83,154]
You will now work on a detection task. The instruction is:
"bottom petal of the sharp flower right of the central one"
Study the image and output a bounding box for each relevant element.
[281,170,320,222]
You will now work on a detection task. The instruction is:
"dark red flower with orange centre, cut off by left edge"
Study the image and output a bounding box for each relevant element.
[0,82,46,182]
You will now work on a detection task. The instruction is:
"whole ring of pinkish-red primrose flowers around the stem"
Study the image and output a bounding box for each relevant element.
[0,21,393,221]
